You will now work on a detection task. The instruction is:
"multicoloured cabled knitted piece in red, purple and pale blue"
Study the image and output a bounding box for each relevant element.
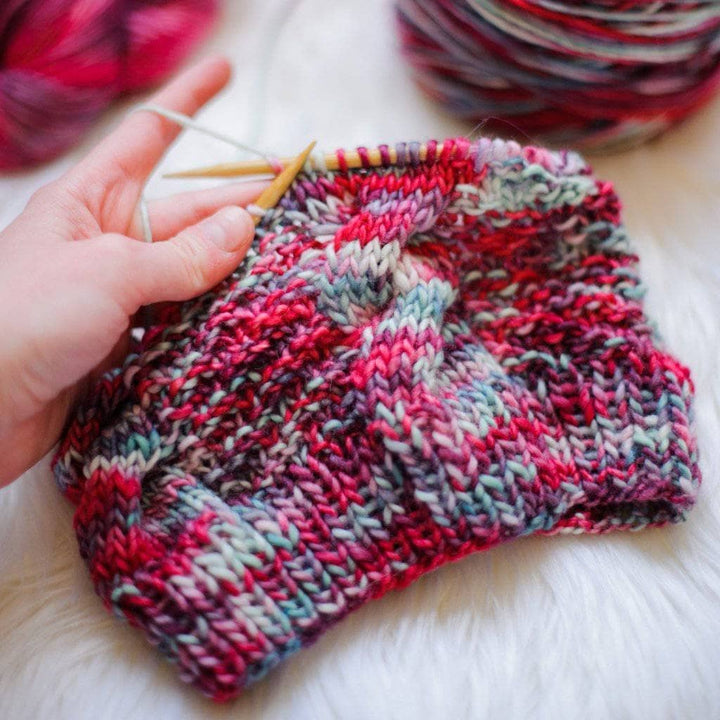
[54,139,699,699]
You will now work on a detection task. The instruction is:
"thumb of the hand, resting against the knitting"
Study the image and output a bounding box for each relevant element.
[125,206,255,305]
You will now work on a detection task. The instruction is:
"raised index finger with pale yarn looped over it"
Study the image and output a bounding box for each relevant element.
[75,57,230,187]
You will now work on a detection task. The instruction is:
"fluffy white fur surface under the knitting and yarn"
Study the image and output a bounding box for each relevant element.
[0,0,720,720]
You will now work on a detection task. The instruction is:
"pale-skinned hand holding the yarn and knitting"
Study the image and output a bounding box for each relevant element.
[0,58,263,487]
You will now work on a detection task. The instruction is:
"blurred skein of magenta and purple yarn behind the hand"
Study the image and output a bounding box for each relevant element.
[0,0,218,170]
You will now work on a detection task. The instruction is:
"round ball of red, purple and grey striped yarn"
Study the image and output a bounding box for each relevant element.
[396,0,720,151]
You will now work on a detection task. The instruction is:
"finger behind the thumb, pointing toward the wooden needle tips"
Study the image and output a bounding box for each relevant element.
[128,182,267,241]
